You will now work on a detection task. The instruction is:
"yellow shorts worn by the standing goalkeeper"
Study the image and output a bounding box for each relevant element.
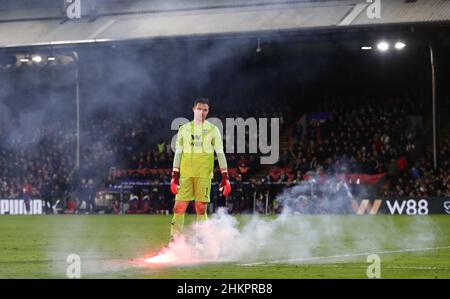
[175,177,211,202]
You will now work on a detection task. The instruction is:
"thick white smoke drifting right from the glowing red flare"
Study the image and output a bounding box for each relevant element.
[147,179,438,266]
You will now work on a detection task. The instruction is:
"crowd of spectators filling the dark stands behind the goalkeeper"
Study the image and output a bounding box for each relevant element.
[0,99,450,213]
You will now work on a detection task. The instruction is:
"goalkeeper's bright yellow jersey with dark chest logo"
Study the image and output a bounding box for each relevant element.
[176,120,223,178]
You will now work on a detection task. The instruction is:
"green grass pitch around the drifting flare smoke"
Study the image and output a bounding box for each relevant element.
[0,215,450,279]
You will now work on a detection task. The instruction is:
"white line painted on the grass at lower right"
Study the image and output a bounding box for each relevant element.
[238,246,450,266]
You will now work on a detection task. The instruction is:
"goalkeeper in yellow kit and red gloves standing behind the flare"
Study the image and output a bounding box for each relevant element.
[170,99,231,240]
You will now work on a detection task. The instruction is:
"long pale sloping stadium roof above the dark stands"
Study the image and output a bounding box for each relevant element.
[0,0,450,47]
